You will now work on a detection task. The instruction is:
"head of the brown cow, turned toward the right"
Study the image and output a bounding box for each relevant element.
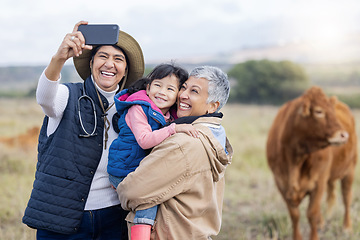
[294,87,349,151]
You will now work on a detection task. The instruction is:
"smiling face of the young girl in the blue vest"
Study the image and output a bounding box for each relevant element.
[146,75,179,115]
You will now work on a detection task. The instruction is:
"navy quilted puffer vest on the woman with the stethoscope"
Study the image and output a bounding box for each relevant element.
[23,78,108,234]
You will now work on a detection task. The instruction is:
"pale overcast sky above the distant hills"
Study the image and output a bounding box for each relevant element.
[0,0,360,66]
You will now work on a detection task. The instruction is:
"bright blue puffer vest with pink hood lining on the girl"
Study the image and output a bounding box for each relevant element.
[107,89,166,177]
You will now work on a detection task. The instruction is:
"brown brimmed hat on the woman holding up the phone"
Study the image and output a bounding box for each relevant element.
[73,31,145,88]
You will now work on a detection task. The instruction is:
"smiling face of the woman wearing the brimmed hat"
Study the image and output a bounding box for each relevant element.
[90,46,126,92]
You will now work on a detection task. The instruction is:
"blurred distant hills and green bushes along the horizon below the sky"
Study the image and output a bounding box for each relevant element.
[0,60,360,108]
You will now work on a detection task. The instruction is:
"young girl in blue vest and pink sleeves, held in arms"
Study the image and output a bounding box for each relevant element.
[108,64,198,239]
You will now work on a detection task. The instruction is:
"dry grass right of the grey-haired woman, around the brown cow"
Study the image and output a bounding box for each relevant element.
[215,105,360,240]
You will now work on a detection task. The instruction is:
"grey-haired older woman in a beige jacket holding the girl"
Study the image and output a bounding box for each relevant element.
[117,66,232,240]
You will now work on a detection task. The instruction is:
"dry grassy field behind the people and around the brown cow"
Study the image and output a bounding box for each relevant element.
[0,99,360,240]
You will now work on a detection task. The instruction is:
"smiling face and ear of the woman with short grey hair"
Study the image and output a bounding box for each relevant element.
[177,77,219,117]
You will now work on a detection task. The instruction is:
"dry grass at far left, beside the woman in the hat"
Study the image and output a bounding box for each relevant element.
[0,99,43,240]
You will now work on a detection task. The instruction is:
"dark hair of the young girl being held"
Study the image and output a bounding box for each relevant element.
[128,63,189,94]
